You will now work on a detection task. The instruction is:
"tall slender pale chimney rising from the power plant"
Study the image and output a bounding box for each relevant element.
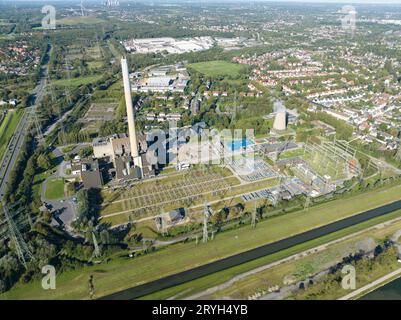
[121,58,139,158]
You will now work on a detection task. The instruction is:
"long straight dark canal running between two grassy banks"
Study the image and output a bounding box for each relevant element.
[100,200,401,300]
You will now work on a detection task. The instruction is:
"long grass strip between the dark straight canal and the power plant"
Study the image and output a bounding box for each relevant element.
[0,182,401,299]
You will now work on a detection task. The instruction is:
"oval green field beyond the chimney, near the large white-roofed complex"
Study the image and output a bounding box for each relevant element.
[188,60,244,77]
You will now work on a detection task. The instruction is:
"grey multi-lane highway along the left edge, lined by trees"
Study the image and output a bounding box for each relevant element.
[0,44,51,202]
